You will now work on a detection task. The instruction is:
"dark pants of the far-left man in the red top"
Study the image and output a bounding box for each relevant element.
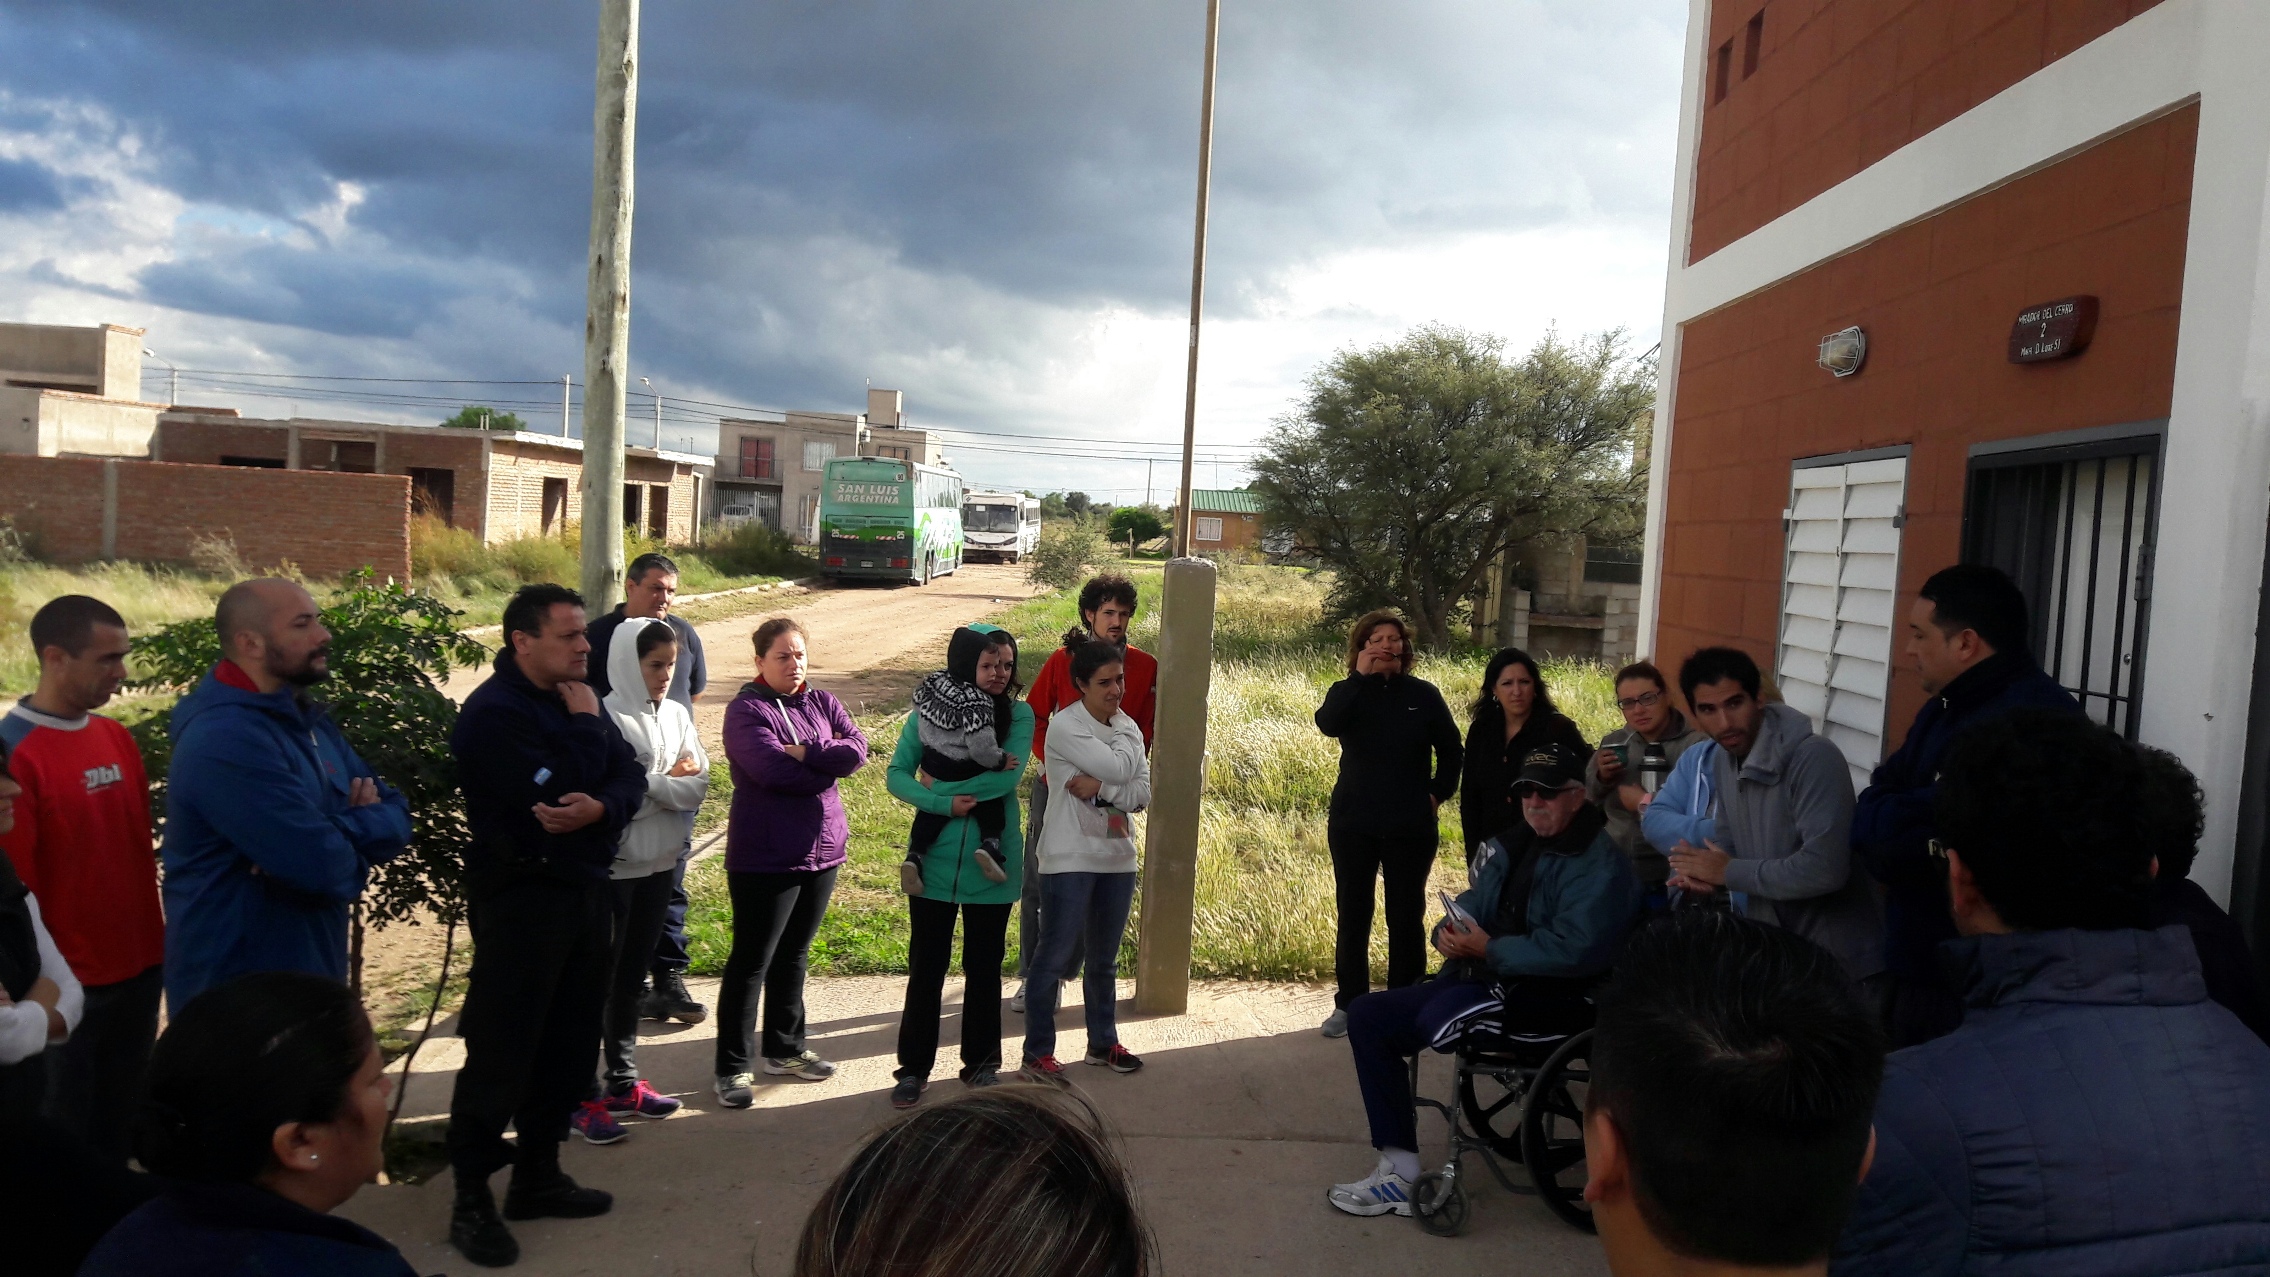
[41,964,166,1166]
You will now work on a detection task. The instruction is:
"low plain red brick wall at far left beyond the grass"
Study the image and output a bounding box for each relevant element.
[0,456,411,578]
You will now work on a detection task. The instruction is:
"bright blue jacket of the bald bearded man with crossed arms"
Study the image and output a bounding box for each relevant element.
[161,667,411,1007]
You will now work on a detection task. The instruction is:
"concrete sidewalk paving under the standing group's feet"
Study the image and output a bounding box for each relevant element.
[341,978,1607,1277]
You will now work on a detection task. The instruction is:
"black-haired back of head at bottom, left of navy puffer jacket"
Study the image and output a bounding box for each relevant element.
[1584,910,1884,1268]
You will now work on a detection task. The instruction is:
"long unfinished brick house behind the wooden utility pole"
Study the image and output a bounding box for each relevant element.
[150,408,713,542]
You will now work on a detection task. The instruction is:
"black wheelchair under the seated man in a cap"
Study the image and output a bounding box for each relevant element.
[1412,1025,1594,1236]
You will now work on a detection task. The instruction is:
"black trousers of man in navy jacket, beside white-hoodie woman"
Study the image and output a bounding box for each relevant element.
[449,878,615,1177]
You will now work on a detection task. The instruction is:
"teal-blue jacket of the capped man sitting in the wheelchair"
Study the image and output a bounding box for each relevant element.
[1437,807,1643,980]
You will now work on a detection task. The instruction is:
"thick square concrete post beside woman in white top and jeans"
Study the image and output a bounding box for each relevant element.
[1135,558,1214,1016]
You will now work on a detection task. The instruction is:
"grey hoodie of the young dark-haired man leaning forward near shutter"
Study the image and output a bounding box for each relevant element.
[1712,703,1884,980]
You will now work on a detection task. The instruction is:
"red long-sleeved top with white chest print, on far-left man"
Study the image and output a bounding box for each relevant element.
[0,703,166,984]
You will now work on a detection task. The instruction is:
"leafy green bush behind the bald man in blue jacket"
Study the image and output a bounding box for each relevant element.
[134,567,488,984]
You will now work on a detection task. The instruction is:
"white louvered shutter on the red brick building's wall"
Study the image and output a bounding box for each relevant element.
[1777,456,1907,789]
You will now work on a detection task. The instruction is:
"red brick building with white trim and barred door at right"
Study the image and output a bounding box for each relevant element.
[1641,0,2270,920]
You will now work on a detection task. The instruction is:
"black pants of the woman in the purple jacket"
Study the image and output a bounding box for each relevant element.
[717,864,842,1077]
